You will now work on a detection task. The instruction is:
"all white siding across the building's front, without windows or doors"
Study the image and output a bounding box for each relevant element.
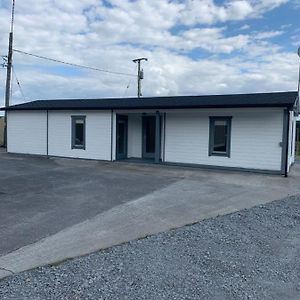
[8,108,292,171]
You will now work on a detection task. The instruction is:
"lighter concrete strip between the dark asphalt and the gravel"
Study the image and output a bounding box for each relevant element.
[0,158,300,278]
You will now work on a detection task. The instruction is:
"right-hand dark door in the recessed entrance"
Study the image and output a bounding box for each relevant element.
[142,116,155,158]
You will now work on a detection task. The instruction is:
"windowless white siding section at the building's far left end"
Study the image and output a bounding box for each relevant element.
[7,111,47,155]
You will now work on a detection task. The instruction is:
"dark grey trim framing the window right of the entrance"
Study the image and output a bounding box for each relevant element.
[208,116,232,157]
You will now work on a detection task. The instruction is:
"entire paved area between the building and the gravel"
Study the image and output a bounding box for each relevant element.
[0,151,300,278]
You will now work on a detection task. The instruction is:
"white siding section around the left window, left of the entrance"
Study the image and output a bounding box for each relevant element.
[48,111,111,160]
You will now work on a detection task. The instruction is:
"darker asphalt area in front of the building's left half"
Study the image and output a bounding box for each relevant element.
[0,149,178,256]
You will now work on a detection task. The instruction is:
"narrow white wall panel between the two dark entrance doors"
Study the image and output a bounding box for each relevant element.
[128,114,142,157]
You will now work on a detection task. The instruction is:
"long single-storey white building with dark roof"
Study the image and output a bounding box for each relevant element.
[2,92,299,175]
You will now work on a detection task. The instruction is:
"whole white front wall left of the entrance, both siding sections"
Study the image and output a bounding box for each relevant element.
[7,111,111,160]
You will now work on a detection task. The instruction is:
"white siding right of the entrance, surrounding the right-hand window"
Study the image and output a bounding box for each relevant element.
[165,108,283,171]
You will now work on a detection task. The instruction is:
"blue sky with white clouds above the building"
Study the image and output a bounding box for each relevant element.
[0,0,300,106]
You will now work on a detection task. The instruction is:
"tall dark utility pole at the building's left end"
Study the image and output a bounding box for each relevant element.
[4,0,15,147]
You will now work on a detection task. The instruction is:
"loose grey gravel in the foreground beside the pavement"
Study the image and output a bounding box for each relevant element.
[0,196,300,300]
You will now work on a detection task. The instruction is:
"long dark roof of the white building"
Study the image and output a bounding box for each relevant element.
[1,92,297,110]
